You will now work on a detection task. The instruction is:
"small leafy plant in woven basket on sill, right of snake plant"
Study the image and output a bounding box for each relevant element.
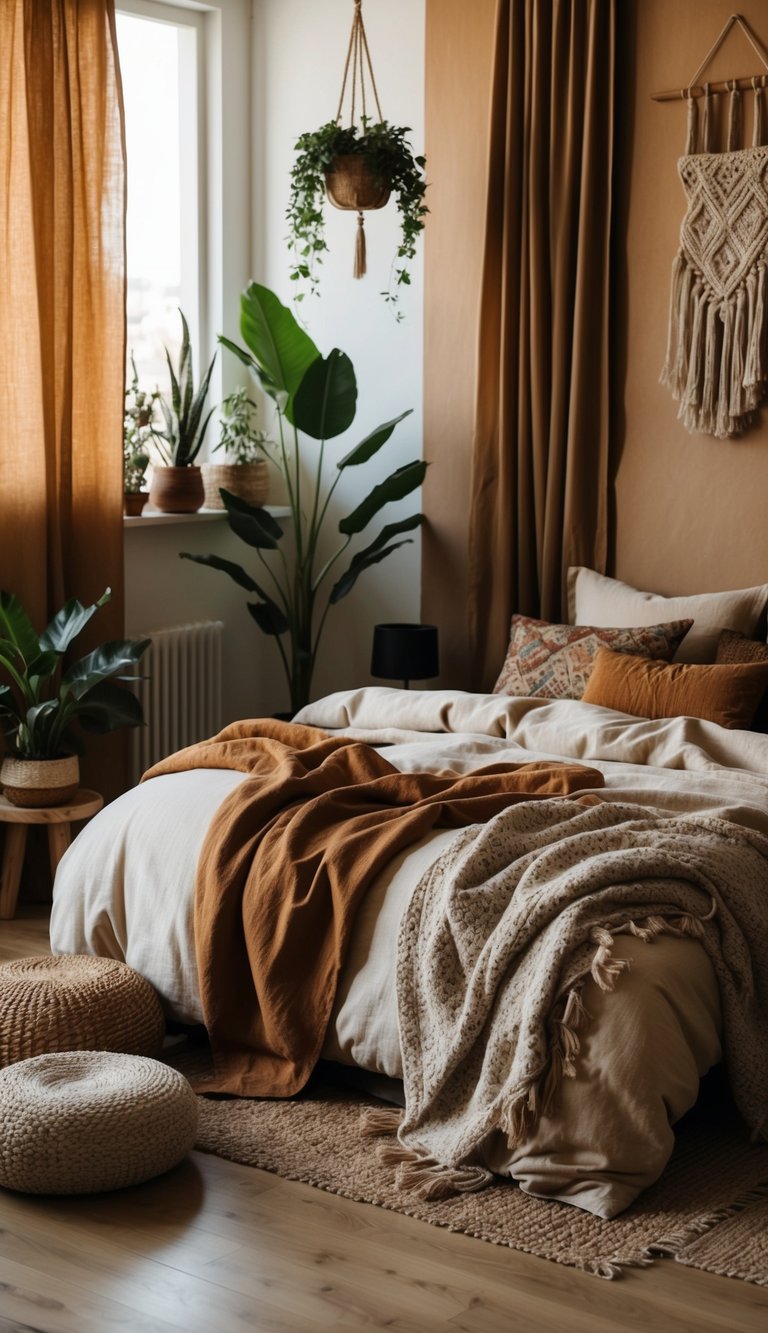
[201,387,273,509]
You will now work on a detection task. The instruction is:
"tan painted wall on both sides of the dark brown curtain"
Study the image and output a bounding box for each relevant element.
[421,0,768,688]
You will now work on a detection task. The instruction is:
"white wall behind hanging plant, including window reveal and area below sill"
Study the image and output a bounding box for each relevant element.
[125,0,424,720]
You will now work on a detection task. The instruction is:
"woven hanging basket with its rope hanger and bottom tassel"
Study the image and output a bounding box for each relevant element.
[325,0,389,277]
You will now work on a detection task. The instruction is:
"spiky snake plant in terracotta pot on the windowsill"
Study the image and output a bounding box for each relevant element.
[149,311,216,513]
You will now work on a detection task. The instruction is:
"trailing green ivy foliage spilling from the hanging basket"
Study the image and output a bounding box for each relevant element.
[287,116,429,320]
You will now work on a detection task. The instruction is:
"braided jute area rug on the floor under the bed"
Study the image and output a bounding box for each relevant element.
[186,1085,768,1286]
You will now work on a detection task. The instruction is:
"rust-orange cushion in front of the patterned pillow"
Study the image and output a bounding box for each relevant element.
[581,648,768,728]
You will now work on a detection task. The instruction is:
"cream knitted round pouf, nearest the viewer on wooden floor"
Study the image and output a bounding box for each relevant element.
[0,1050,197,1194]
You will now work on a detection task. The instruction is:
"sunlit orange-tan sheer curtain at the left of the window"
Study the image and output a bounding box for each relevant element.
[0,0,125,789]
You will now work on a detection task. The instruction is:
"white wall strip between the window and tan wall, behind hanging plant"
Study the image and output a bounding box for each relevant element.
[252,0,424,696]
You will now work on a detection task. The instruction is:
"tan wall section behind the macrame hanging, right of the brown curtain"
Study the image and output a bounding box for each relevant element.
[615,0,768,593]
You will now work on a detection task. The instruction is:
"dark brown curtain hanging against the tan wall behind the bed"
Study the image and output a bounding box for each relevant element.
[469,0,615,688]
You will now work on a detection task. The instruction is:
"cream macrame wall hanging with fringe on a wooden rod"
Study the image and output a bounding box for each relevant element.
[655,15,768,439]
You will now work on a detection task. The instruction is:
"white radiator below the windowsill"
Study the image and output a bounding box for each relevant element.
[133,620,224,781]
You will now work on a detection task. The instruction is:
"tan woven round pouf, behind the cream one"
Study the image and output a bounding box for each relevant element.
[0,953,165,1069]
